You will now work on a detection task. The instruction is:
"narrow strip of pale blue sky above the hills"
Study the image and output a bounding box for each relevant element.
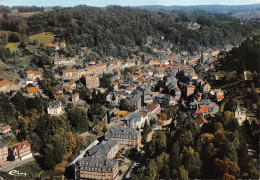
[0,0,260,7]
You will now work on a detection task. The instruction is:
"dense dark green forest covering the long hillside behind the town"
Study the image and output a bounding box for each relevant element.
[0,6,257,57]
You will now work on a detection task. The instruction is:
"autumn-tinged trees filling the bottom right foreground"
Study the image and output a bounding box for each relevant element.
[132,111,259,180]
